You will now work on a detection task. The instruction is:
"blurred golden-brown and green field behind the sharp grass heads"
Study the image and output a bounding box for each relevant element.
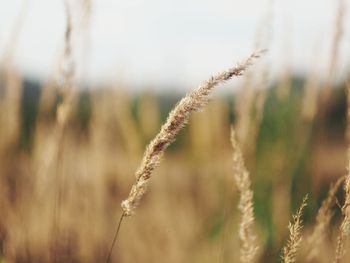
[0,0,350,263]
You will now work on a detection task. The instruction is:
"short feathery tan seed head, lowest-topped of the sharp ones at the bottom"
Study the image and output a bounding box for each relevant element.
[282,195,308,263]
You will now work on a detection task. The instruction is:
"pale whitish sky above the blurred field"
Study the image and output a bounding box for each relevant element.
[0,0,350,89]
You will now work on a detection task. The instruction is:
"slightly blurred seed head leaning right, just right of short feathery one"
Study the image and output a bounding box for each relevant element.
[307,178,344,262]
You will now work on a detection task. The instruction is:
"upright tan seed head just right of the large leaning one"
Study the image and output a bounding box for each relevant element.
[231,128,258,263]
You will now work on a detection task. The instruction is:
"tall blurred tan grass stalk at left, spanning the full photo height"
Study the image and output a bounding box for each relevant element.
[47,0,75,262]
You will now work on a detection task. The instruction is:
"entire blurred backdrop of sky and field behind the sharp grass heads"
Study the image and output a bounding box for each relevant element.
[0,0,350,263]
